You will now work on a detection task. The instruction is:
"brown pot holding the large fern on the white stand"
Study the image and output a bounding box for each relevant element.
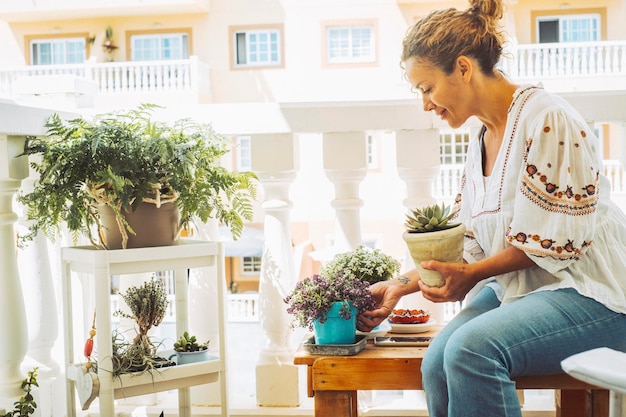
[98,203,180,249]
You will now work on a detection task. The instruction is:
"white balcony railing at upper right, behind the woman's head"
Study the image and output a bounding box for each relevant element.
[503,40,626,79]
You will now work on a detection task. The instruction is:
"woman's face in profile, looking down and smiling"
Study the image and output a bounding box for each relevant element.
[404,57,472,128]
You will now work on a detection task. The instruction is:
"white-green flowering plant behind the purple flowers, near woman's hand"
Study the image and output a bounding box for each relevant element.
[320,245,400,284]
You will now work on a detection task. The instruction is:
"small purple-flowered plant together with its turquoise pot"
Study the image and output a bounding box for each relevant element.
[284,274,374,344]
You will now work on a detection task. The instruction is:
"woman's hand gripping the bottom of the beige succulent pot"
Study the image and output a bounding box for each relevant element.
[419,260,476,303]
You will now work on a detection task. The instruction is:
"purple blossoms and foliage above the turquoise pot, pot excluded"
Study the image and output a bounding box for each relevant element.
[283,274,374,330]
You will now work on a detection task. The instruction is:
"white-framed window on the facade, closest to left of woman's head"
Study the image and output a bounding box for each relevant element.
[326,25,376,64]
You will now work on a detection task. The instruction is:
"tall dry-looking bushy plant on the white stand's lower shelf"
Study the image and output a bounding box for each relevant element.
[112,276,169,375]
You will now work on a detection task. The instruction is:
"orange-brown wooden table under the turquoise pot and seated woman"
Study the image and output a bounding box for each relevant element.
[294,327,609,417]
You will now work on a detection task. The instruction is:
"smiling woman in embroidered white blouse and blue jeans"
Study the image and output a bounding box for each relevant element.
[359,0,626,417]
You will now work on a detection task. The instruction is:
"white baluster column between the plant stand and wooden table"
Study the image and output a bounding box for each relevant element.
[252,134,300,407]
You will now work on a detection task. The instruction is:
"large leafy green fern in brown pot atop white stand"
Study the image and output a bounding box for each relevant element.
[18,104,256,249]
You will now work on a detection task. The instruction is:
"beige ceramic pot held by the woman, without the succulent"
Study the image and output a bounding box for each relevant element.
[402,224,465,287]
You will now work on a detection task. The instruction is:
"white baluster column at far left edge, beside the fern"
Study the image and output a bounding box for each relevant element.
[0,134,28,410]
